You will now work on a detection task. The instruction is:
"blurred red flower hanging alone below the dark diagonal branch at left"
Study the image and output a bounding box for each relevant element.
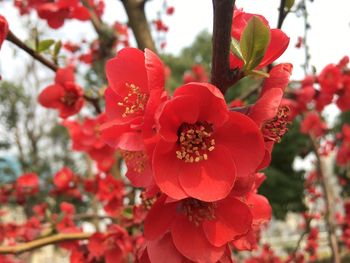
[38,67,84,118]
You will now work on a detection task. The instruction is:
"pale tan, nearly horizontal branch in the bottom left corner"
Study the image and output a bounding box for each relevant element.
[0,233,93,254]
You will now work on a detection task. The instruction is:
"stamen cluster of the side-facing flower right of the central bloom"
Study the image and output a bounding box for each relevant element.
[261,106,290,142]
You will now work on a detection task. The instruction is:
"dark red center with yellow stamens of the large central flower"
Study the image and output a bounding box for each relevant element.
[176,121,215,163]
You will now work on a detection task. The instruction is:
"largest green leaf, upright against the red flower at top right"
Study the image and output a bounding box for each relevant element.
[240,16,270,71]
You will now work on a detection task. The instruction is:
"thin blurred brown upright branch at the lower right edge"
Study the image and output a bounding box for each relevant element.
[309,133,340,263]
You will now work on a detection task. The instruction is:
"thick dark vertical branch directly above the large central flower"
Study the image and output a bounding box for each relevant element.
[211,0,241,94]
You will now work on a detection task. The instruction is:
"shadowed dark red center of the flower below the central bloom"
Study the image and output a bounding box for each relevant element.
[180,198,216,226]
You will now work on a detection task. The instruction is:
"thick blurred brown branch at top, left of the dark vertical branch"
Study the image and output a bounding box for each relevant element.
[121,0,156,51]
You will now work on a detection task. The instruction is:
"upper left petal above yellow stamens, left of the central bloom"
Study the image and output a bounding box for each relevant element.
[106,48,149,97]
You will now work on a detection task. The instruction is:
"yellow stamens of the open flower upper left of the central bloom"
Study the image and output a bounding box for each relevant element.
[118,83,149,118]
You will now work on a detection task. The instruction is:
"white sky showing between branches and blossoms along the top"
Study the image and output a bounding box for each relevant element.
[0,0,350,79]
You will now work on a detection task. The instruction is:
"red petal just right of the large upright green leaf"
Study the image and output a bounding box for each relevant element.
[259,29,289,68]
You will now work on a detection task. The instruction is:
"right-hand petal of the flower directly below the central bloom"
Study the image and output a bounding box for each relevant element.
[203,198,252,247]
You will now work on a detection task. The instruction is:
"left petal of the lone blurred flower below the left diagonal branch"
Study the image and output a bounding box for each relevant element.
[38,84,64,108]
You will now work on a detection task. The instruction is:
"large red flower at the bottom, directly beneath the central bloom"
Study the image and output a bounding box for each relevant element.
[144,195,252,262]
